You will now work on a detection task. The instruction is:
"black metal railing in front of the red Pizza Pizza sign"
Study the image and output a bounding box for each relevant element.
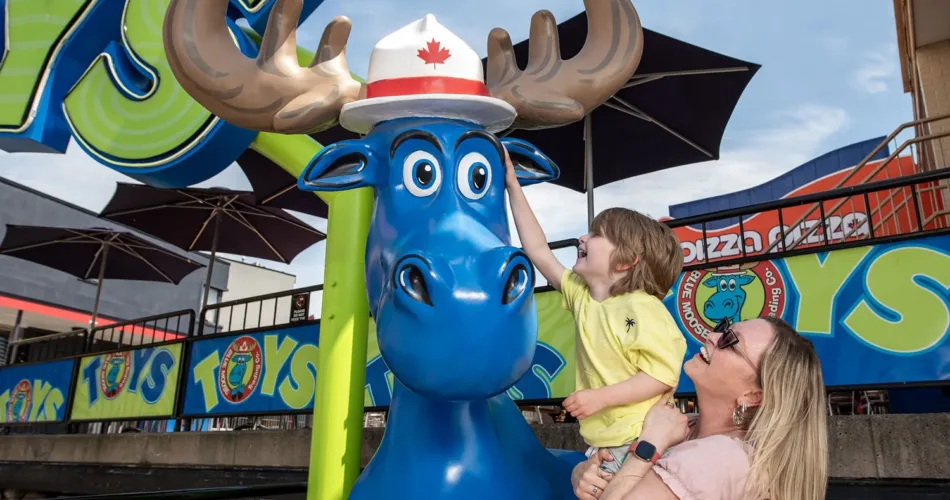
[666,169,950,270]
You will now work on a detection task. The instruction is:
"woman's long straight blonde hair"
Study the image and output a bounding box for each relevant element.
[746,317,828,500]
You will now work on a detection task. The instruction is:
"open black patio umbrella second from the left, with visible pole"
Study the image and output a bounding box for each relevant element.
[101,183,326,307]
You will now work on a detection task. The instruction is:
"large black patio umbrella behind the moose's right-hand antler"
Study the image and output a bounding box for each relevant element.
[482,12,761,227]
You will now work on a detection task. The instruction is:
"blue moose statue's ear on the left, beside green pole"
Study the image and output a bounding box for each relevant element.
[297,140,377,191]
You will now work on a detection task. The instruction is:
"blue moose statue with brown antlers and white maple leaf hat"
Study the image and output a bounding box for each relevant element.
[164,0,643,500]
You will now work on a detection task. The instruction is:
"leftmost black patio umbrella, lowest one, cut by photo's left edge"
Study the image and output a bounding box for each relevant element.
[0,224,204,328]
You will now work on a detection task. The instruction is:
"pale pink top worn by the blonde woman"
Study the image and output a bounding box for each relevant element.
[653,422,752,500]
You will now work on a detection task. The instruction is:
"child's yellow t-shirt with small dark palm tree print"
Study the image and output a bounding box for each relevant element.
[561,269,686,448]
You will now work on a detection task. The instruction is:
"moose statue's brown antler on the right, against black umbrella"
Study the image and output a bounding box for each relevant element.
[486,0,643,129]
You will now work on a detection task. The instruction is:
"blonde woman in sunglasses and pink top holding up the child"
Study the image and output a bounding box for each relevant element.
[571,318,828,500]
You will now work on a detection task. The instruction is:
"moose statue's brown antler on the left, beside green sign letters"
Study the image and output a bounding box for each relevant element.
[163,0,364,134]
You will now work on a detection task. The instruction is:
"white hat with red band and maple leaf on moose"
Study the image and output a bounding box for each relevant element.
[340,14,517,134]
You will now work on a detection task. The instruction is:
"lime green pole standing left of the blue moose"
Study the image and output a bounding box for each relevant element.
[251,133,373,500]
